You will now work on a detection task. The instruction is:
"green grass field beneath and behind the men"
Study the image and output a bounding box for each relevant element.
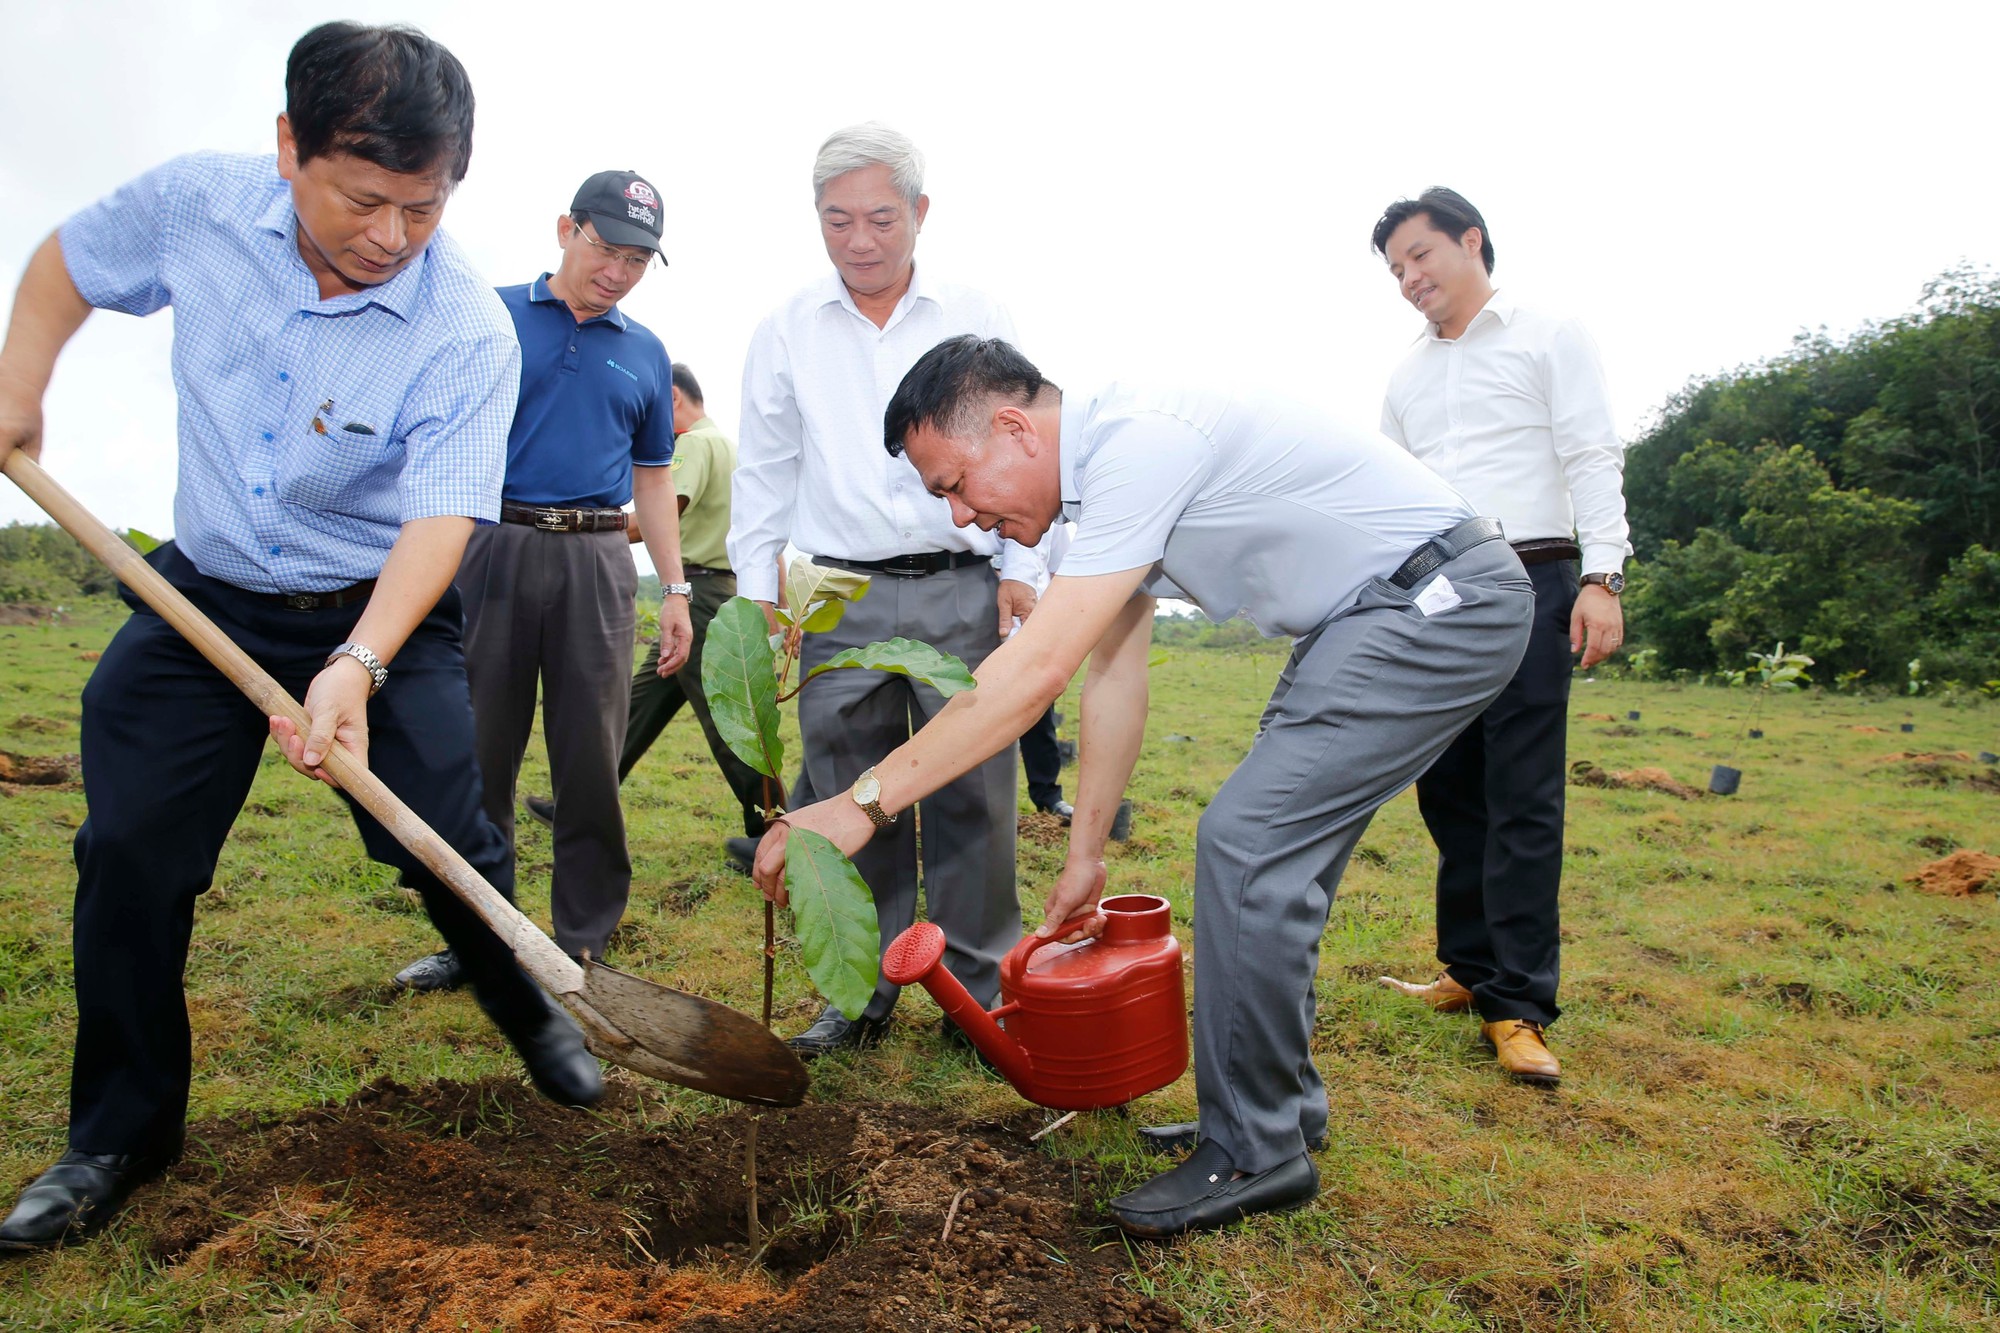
[0,606,2000,1333]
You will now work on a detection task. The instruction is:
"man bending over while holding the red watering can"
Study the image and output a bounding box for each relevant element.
[756,336,1534,1237]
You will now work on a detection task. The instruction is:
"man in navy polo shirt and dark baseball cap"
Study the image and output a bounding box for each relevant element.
[396,172,694,991]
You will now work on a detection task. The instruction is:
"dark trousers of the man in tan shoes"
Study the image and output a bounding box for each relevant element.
[1416,560,1576,1025]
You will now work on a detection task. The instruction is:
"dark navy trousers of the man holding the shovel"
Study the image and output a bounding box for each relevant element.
[70,542,546,1155]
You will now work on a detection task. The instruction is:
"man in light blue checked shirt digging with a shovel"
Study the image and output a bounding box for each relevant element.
[0,22,602,1249]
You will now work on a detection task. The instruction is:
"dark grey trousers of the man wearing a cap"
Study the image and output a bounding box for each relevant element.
[458,522,638,959]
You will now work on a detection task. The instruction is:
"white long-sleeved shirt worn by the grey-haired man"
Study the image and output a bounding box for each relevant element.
[730,268,1044,602]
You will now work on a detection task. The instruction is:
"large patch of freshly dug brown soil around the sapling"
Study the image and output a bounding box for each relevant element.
[137,1079,1180,1333]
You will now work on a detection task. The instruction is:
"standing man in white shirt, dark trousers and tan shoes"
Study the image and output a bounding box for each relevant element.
[1374,188,1632,1083]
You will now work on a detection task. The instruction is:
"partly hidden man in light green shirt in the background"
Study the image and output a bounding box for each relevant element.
[528,360,764,860]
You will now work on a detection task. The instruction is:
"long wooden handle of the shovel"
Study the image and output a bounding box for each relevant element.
[0,448,584,995]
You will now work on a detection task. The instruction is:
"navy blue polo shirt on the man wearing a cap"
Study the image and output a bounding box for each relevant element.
[500,272,674,508]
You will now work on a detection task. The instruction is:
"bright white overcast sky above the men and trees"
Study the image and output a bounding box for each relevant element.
[0,0,2000,560]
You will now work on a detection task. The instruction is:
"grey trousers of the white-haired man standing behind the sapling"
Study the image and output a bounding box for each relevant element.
[798,556,1022,1019]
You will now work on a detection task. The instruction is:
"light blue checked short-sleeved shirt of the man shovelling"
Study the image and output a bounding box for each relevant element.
[62,152,520,592]
